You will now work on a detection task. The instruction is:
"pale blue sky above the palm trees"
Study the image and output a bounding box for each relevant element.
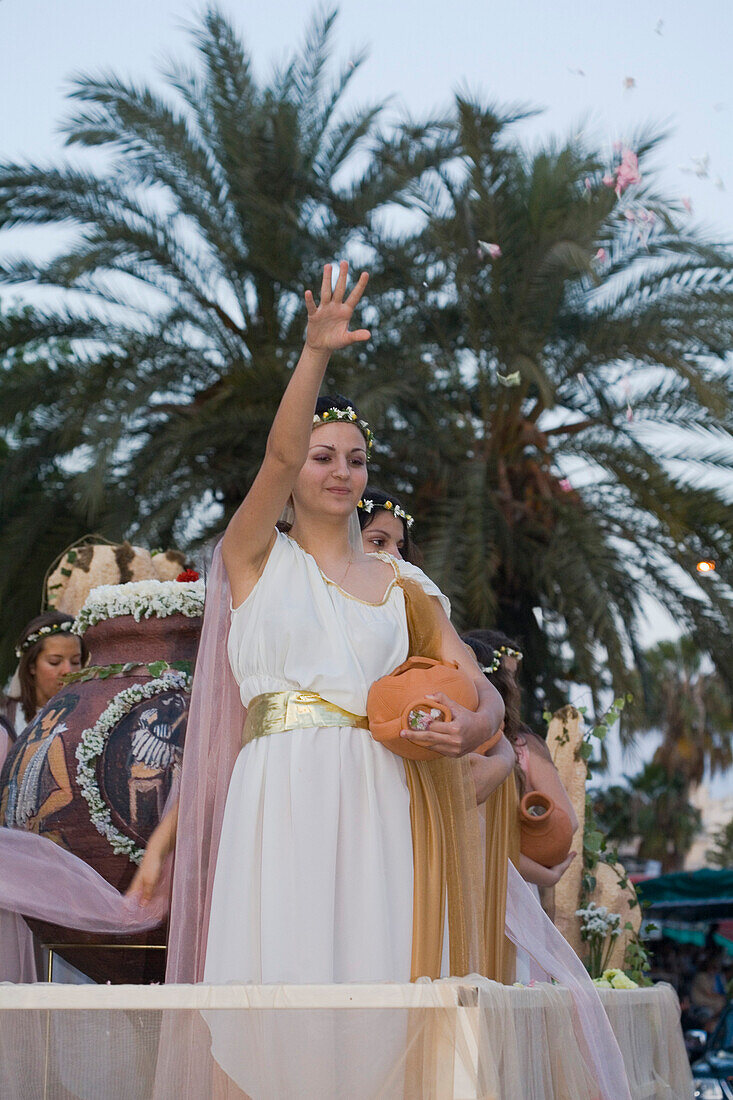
[0,0,733,793]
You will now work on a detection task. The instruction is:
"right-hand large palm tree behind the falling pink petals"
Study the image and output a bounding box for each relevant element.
[391,100,733,721]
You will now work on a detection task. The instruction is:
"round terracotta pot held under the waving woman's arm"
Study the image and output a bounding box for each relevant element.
[367,657,479,760]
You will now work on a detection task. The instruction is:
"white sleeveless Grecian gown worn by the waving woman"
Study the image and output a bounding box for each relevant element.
[205,532,447,983]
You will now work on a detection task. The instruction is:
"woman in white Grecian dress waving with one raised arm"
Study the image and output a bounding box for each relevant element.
[205,264,512,982]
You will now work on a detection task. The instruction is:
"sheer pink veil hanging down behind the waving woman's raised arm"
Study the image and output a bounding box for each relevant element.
[165,543,245,982]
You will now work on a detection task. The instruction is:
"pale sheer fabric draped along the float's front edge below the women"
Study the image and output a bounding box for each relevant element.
[0,976,691,1100]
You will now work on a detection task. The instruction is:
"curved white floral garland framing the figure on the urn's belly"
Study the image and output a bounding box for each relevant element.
[76,670,192,864]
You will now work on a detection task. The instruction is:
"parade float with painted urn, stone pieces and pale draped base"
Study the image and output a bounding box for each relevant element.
[0,548,690,1100]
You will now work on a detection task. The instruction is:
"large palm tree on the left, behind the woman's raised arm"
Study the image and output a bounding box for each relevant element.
[0,8,452,660]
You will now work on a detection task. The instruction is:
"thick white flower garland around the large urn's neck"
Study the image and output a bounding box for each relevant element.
[73,581,205,635]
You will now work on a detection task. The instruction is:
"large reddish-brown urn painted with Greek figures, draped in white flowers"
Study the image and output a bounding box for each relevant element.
[0,572,204,982]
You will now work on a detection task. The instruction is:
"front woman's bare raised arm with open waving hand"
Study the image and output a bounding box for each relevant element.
[221,263,371,605]
